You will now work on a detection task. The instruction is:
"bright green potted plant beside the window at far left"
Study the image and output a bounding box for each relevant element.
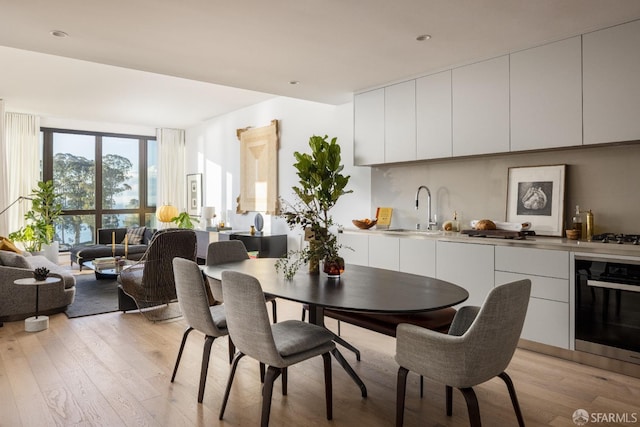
[9,180,62,263]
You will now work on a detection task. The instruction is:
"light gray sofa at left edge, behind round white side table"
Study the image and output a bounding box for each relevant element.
[0,250,76,323]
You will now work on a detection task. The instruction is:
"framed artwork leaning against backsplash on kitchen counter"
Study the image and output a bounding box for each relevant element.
[507,165,566,236]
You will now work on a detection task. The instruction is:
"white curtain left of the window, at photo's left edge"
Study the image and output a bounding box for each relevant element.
[0,113,41,236]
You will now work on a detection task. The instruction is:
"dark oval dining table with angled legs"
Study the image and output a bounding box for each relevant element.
[201,258,469,397]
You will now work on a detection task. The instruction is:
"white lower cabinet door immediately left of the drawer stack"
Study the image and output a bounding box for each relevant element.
[436,241,494,306]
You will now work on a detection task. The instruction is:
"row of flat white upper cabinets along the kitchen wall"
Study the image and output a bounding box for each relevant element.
[354,20,640,165]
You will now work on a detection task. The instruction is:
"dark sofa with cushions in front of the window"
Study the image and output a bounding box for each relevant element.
[69,227,154,270]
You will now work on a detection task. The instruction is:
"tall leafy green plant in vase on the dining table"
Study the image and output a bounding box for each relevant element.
[276,135,352,278]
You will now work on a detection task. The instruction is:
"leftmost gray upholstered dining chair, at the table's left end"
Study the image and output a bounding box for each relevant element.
[171,258,234,403]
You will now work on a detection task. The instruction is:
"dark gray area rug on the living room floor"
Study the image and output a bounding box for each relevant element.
[66,274,118,319]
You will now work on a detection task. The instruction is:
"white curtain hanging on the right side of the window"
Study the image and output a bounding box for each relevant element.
[156,129,187,212]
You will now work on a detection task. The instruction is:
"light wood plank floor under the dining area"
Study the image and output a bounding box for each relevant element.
[0,300,640,427]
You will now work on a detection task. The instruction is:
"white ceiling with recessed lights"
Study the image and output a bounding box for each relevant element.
[0,0,640,128]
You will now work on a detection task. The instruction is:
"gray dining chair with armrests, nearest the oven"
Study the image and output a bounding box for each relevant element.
[395,279,531,427]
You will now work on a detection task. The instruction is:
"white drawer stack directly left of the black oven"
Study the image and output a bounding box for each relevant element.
[495,246,571,349]
